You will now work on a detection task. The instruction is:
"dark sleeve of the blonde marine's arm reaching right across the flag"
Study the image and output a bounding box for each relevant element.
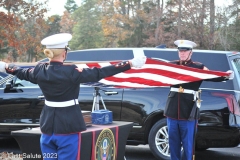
[73,61,131,83]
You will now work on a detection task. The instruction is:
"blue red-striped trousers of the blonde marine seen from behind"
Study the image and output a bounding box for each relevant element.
[40,133,81,160]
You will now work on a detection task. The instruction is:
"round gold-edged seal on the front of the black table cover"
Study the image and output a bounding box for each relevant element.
[95,128,116,160]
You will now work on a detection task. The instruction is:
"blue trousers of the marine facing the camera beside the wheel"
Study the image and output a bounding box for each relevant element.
[167,118,197,160]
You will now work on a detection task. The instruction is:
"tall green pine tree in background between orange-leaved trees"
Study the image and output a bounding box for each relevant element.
[69,0,104,49]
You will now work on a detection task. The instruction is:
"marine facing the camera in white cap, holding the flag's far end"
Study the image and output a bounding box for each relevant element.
[164,40,232,160]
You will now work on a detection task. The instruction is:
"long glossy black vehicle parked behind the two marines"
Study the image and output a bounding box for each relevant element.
[0,48,240,159]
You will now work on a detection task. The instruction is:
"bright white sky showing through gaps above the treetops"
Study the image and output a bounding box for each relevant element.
[42,0,231,16]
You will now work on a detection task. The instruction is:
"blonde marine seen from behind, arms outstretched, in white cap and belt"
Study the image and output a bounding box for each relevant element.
[1,33,146,160]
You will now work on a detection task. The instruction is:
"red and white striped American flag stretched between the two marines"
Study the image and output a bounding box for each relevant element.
[78,58,229,88]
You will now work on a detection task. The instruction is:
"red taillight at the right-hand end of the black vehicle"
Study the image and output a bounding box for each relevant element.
[212,92,240,116]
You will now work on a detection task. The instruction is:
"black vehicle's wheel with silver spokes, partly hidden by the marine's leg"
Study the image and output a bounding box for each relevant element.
[148,118,170,160]
